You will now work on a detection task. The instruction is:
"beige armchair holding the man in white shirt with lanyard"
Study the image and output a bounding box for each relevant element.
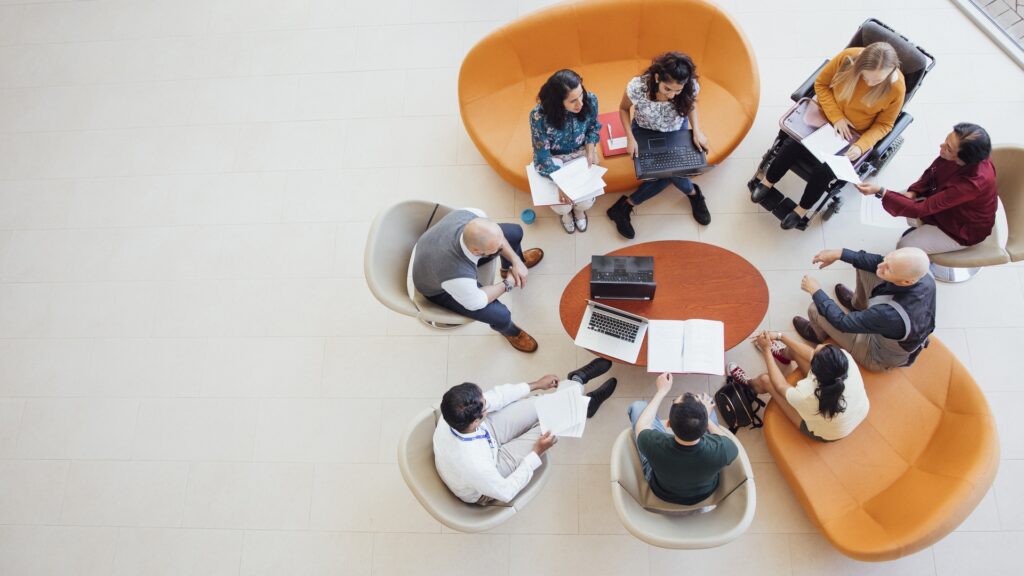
[398,408,551,532]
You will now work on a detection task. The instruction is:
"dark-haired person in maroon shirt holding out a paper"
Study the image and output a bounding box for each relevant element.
[857,123,998,254]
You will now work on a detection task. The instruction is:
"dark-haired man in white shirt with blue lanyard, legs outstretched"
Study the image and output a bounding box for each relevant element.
[434,358,616,504]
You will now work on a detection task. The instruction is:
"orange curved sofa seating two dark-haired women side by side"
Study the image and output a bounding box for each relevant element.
[459,0,761,192]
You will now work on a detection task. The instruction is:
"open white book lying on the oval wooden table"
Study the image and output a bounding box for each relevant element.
[647,320,725,376]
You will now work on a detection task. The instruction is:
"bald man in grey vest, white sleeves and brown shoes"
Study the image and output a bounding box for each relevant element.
[413,208,544,353]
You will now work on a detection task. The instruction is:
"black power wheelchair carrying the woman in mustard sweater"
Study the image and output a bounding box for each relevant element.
[746,18,935,230]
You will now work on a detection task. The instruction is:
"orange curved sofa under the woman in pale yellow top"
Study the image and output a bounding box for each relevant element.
[764,337,999,562]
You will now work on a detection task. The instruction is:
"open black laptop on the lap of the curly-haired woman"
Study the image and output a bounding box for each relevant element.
[633,126,710,180]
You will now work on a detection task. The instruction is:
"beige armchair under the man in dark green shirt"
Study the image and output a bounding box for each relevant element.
[611,428,757,549]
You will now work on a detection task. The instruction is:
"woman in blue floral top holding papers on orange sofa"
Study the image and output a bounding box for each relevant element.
[529,70,601,234]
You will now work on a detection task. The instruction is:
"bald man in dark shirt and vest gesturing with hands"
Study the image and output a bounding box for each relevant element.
[793,247,935,372]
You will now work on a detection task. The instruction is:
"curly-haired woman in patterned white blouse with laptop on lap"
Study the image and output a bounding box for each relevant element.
[608,52,711,238]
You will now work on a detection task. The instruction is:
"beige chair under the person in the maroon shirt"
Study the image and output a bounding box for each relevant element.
[932,146,1024,282]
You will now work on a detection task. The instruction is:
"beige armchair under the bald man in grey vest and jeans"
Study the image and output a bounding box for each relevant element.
[362,200,499,329]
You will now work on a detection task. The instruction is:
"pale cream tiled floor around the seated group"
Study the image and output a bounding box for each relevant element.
[0,0,1024,576]
